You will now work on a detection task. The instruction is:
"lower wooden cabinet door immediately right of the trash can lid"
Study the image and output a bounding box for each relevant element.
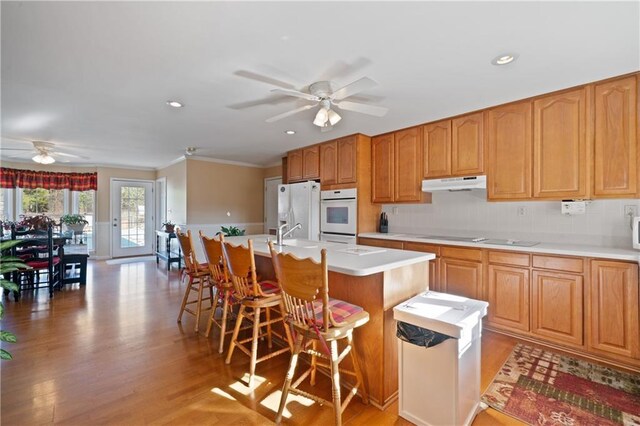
[487,265,529,331]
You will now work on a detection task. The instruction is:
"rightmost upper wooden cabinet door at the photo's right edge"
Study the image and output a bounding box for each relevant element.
[593,76,638,198]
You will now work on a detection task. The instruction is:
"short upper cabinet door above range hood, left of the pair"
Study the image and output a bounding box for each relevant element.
[422,120,451,179]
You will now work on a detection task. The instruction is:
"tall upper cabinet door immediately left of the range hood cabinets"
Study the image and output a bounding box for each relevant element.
[394,127,422,202]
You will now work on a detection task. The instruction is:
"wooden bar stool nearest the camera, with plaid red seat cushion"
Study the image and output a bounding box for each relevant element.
[269,242,369,425]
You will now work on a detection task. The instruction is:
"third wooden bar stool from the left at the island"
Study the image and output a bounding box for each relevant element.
[221,238,292,386]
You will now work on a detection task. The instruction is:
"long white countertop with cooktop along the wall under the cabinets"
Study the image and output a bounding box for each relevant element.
[358,232,640,262]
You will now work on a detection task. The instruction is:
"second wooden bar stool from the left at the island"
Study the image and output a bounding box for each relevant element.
[200,231,234,353]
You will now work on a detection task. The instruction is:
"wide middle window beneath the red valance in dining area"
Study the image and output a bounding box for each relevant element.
[16,188,69,222]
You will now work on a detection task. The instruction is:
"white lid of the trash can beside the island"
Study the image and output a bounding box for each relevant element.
[393,291,489,339]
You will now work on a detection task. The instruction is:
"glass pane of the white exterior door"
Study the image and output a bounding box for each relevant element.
[120,186,146,248]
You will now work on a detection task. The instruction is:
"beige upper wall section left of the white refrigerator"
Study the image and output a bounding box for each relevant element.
[187,159,265,224]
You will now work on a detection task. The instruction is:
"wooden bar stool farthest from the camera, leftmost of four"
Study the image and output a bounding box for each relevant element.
[176,228,214,333]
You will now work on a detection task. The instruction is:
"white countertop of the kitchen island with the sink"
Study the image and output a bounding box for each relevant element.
[225,234,435,276]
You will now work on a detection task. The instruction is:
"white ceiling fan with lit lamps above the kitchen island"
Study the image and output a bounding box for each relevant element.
[266,77,389,131]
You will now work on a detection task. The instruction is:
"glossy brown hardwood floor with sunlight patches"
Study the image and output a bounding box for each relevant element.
[0,261,518,425]
